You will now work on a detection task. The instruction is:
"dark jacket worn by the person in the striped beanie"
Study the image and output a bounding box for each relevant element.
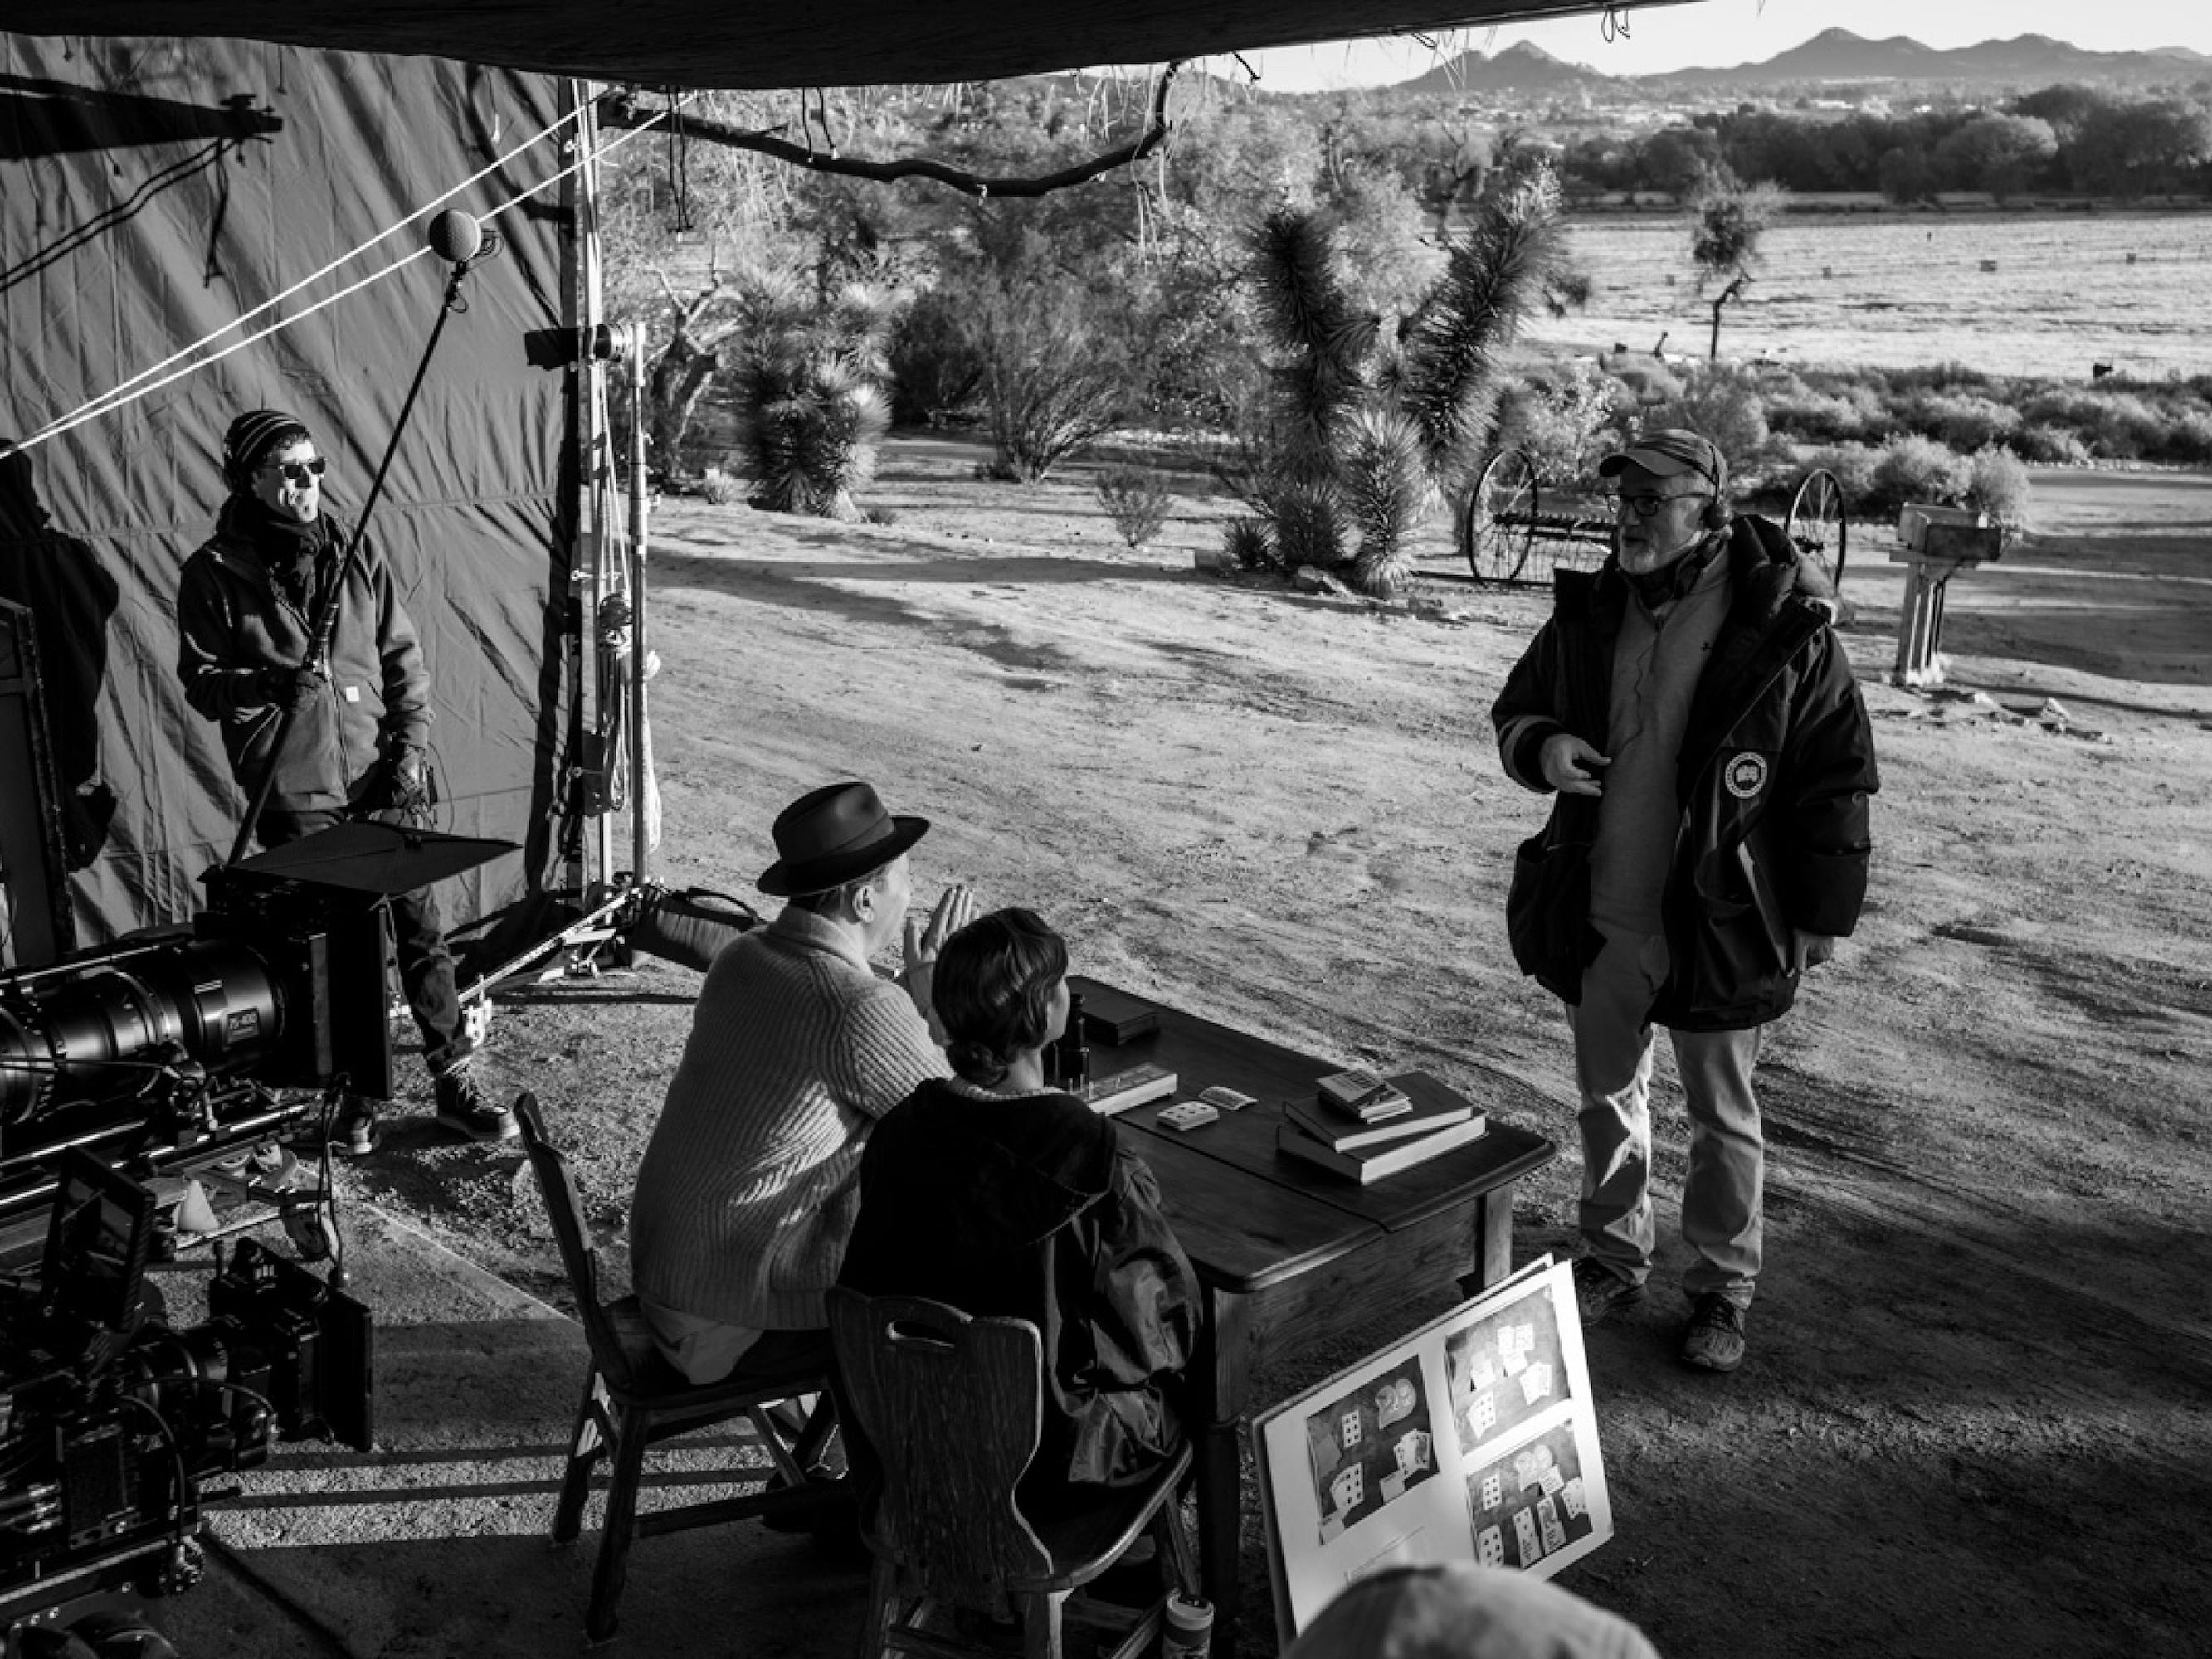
[177,495,431,812]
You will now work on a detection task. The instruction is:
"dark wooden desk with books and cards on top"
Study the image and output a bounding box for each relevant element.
[1069,975,1557,1659]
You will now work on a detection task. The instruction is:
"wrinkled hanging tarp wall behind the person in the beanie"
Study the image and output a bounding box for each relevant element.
[0,33,571,945]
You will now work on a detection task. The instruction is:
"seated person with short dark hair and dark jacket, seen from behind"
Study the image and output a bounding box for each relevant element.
[838,909,1199,1511]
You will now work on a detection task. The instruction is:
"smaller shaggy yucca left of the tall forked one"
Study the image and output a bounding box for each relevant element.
[737,272,891,520]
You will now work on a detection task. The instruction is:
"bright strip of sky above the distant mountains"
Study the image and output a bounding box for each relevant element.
[1206,0,2212,93]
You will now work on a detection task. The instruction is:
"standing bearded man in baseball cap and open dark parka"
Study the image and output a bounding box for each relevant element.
[1491,427,1878,1371]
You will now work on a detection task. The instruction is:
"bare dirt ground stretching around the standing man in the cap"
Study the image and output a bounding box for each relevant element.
[348,438,2212,1659]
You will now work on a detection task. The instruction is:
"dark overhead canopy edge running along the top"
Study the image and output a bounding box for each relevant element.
[9,0,1674,86]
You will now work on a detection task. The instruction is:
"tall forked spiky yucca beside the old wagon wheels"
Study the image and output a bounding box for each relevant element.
[1239,166,1560,597]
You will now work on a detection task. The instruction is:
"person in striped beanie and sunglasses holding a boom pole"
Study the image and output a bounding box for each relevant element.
[177,409,518,1155]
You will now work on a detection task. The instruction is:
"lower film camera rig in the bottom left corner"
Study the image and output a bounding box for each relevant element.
[0,1148,374,1659]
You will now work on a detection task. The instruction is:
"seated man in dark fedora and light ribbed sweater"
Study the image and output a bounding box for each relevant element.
[631,783,976,1383]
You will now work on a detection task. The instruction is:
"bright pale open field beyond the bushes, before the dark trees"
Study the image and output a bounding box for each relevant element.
[1527,210,2212,381]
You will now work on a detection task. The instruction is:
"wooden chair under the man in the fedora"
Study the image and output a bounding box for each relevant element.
[515,1095,850,1642]
